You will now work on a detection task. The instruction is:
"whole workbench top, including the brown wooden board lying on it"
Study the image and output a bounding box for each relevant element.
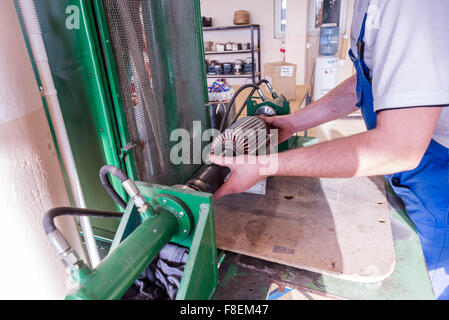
[214,137,434,299]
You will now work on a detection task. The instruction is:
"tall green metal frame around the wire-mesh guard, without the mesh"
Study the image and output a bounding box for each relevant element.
[16,0,208,245]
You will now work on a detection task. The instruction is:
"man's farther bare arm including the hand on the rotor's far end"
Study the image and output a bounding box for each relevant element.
[264,75,357,142]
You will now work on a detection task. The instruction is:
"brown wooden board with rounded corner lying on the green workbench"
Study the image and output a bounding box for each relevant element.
[215,177,395,282]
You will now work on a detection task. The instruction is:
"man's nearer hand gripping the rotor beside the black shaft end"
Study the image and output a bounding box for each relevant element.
[209,154,267,199]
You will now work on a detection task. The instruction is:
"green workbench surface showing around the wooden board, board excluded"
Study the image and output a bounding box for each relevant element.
[213,185,435,300]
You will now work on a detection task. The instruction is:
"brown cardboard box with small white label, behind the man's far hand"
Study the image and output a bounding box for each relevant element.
[263,62,296,100]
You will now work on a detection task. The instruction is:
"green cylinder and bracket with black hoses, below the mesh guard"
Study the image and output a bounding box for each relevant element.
[43,166,217,300]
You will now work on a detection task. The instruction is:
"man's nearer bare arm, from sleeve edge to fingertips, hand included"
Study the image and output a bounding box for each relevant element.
[210,107,441,198]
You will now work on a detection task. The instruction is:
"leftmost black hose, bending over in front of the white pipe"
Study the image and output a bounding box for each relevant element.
[42,207,123,234]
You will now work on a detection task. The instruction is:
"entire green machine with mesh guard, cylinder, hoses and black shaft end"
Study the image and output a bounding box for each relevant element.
[19,0,225,299]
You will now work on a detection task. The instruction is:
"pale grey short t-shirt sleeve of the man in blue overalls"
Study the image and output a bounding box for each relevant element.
[365,0,449,111]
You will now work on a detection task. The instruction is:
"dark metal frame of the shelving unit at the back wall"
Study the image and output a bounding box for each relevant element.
[203,24,261,83]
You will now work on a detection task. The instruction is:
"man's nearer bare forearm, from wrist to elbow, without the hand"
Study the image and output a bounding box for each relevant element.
[276,130,416,178]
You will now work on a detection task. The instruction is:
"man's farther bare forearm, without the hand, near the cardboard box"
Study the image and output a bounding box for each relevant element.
[292,75,357,131]
